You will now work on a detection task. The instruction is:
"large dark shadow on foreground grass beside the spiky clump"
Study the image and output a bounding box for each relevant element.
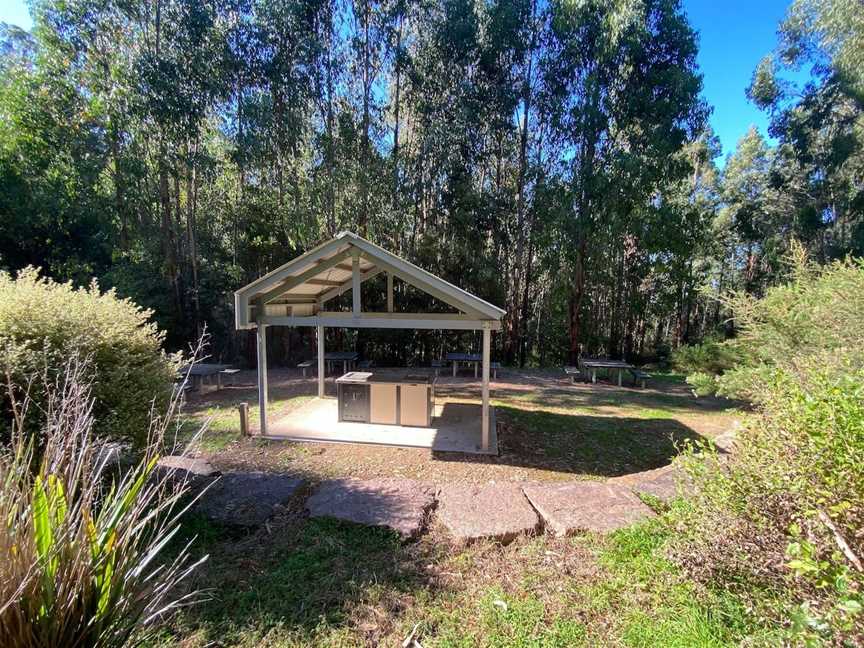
[168,515,435,646]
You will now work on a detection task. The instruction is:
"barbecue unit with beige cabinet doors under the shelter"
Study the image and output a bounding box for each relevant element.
[336,371,435,427]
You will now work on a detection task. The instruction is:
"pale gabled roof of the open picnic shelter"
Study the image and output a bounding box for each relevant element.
[234,232,504,329]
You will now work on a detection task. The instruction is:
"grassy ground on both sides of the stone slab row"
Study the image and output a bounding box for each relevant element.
[151,372,750,648]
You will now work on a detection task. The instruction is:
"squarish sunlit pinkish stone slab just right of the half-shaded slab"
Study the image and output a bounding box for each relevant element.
[438,484,540,544]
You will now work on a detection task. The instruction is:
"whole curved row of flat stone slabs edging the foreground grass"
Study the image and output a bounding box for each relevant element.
[189,462,692,544]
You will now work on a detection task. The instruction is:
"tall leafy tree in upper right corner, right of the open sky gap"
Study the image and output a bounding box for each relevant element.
[748,0,864,270]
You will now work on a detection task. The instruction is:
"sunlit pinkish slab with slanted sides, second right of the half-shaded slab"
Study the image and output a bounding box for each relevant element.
[522,481,654,536]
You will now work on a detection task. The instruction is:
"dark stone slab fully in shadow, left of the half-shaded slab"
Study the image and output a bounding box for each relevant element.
[196,472,303,527]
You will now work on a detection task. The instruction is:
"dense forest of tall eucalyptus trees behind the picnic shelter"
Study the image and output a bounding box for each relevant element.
[0,0,864,364]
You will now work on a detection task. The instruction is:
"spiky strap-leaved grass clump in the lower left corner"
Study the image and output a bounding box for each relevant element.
[0,362,208,648]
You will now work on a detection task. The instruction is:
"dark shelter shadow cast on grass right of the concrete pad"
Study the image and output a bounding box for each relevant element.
[435,404,705,477]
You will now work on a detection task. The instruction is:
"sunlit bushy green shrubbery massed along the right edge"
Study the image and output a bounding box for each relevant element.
[680,247,864,645]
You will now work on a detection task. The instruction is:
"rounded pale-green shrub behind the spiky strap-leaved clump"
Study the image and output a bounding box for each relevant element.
[0,268,177,444]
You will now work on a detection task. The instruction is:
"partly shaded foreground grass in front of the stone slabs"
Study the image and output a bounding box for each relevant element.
[153,512,748,648]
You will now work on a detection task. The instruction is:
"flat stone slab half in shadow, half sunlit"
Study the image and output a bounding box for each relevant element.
[306,479,435,538]
